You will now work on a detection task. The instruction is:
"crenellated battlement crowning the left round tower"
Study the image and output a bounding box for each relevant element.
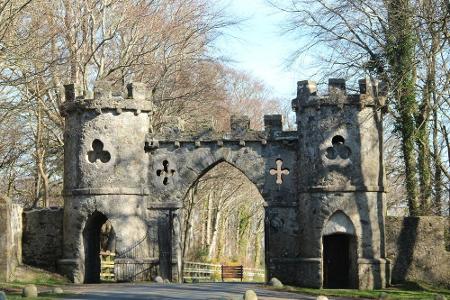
[61,81,153,116]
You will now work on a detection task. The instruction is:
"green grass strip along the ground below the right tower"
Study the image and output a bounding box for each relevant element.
[274,282,450,300]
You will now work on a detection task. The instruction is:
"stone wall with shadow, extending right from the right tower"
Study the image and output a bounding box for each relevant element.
[386,217,450,286]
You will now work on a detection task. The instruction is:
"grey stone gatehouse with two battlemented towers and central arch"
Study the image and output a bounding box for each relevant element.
[58,79,389,289]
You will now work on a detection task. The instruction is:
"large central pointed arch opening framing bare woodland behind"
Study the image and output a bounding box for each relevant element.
[181,160,265,281]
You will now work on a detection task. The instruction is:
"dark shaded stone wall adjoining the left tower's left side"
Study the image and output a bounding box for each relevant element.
[22,208,64,271]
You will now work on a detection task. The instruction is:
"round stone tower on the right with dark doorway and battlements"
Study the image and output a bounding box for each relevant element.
[292,79,388,289]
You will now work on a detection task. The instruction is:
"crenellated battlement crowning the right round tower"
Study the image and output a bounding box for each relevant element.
[292,78,386,112]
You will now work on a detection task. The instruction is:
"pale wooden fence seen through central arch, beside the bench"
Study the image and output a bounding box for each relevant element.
[183,261,266,281]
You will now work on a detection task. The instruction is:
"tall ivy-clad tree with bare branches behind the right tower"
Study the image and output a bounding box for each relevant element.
[269,0,449,215]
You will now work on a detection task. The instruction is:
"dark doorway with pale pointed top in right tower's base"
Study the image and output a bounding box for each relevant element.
[322,211,358,288]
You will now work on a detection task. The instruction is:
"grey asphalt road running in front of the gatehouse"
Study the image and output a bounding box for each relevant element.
[59,283,326,300]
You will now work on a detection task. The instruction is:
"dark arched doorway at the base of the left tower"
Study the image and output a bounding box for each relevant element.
[83,211,116,283]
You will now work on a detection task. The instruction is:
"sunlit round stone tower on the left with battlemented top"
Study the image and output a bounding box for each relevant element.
[59,82,152,283]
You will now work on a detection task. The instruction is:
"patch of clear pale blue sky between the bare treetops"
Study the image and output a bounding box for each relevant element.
[212,0,310,101]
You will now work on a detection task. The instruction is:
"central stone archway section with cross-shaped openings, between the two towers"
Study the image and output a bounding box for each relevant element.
[144,116,300,283]
